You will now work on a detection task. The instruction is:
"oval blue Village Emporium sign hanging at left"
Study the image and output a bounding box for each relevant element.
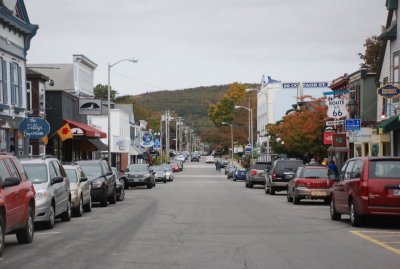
[18,117,50,139]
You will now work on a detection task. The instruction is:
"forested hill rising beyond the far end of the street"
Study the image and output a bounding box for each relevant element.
[133,85,229,132]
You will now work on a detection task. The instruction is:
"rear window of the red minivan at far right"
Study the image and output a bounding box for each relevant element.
[369,160,400,179]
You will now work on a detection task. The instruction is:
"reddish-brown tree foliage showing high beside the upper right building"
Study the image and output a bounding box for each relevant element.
[358,31,383,73]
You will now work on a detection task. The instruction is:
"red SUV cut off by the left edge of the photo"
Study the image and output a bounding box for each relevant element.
[0,154,35,257]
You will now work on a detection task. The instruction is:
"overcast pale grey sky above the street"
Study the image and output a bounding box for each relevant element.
[25,0,387,95]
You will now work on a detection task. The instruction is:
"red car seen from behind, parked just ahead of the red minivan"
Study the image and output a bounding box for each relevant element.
[287,165,336,204]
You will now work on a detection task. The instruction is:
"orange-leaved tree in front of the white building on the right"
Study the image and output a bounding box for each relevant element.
[267,99,327,157]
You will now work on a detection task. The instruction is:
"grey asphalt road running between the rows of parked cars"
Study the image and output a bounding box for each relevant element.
[0,162,400,269]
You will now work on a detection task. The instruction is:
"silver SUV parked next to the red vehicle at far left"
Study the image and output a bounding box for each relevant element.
[20,156,72,229]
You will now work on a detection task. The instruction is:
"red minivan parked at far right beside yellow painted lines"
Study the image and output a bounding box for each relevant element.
[330,157,400,226]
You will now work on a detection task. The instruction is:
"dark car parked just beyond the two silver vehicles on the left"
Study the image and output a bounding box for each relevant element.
[75,159,117,206]
